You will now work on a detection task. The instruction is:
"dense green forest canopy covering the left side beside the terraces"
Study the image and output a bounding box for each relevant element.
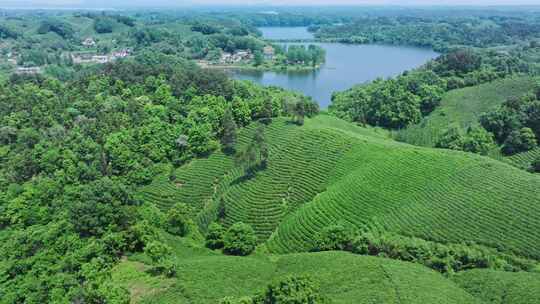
[0,53,316,303]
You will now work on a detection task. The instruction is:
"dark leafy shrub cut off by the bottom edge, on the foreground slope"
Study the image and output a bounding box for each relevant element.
[253,276,325,304]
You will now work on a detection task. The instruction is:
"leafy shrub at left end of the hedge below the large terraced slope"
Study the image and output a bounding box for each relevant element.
[315,224,356,251]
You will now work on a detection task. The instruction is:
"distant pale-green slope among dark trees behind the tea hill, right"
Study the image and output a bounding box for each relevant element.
[396,76,540,169]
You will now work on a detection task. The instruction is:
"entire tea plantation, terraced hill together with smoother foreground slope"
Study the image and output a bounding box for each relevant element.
[130,114,540,304]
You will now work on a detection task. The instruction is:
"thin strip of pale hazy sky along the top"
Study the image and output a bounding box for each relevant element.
[0,0,540,8]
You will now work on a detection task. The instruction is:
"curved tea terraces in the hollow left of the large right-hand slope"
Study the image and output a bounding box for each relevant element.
[221,126,354,240]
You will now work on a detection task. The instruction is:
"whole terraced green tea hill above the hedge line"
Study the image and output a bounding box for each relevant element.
[141,115,540,258]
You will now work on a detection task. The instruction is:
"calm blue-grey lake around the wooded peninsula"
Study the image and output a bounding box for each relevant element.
[231,27,439,108]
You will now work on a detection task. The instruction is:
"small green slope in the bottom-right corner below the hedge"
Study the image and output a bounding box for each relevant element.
[453,270,540,304]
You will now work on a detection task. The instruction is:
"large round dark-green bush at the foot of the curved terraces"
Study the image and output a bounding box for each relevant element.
[223,222,257,256]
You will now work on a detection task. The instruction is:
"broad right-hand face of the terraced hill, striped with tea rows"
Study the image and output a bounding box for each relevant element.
[267,129,540,258]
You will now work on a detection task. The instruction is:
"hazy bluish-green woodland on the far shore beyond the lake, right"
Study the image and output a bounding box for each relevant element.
[315,11,538,51]
